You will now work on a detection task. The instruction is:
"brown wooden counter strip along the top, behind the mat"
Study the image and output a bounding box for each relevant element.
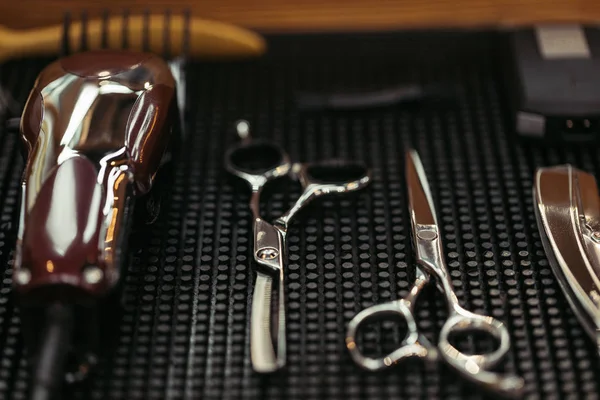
[0,0,600,32]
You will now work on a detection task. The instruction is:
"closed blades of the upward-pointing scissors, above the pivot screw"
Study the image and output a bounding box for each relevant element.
[405,150,437,231]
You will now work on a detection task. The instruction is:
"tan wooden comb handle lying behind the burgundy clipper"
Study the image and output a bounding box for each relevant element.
[0,14,266,62]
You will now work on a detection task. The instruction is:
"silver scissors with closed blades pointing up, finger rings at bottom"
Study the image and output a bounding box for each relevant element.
[346,150,524,397]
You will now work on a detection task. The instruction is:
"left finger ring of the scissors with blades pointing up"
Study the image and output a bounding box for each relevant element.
[346,299,436,371]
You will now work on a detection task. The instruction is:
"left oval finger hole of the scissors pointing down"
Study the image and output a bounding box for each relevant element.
[229,143,285,174]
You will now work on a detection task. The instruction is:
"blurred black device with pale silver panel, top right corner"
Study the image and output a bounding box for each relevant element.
[506,25,600,143]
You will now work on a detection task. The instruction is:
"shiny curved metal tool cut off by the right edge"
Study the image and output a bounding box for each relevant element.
[533,165,600,353]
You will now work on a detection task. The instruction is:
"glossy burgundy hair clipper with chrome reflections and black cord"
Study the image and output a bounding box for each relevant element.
[14,50,177,399]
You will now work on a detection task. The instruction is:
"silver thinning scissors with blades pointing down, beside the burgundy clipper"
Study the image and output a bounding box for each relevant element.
[225,121,371,373]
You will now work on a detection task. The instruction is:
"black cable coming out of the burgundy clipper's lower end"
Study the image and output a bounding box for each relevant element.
[29,303,73,400]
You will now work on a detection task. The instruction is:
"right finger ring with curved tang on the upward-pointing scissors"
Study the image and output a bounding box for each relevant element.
[438,306,524,397]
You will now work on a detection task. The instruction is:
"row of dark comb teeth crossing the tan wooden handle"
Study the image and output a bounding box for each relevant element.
[61,9,191,59]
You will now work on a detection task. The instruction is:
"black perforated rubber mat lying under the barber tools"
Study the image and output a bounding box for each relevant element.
[0,33,600,400]
